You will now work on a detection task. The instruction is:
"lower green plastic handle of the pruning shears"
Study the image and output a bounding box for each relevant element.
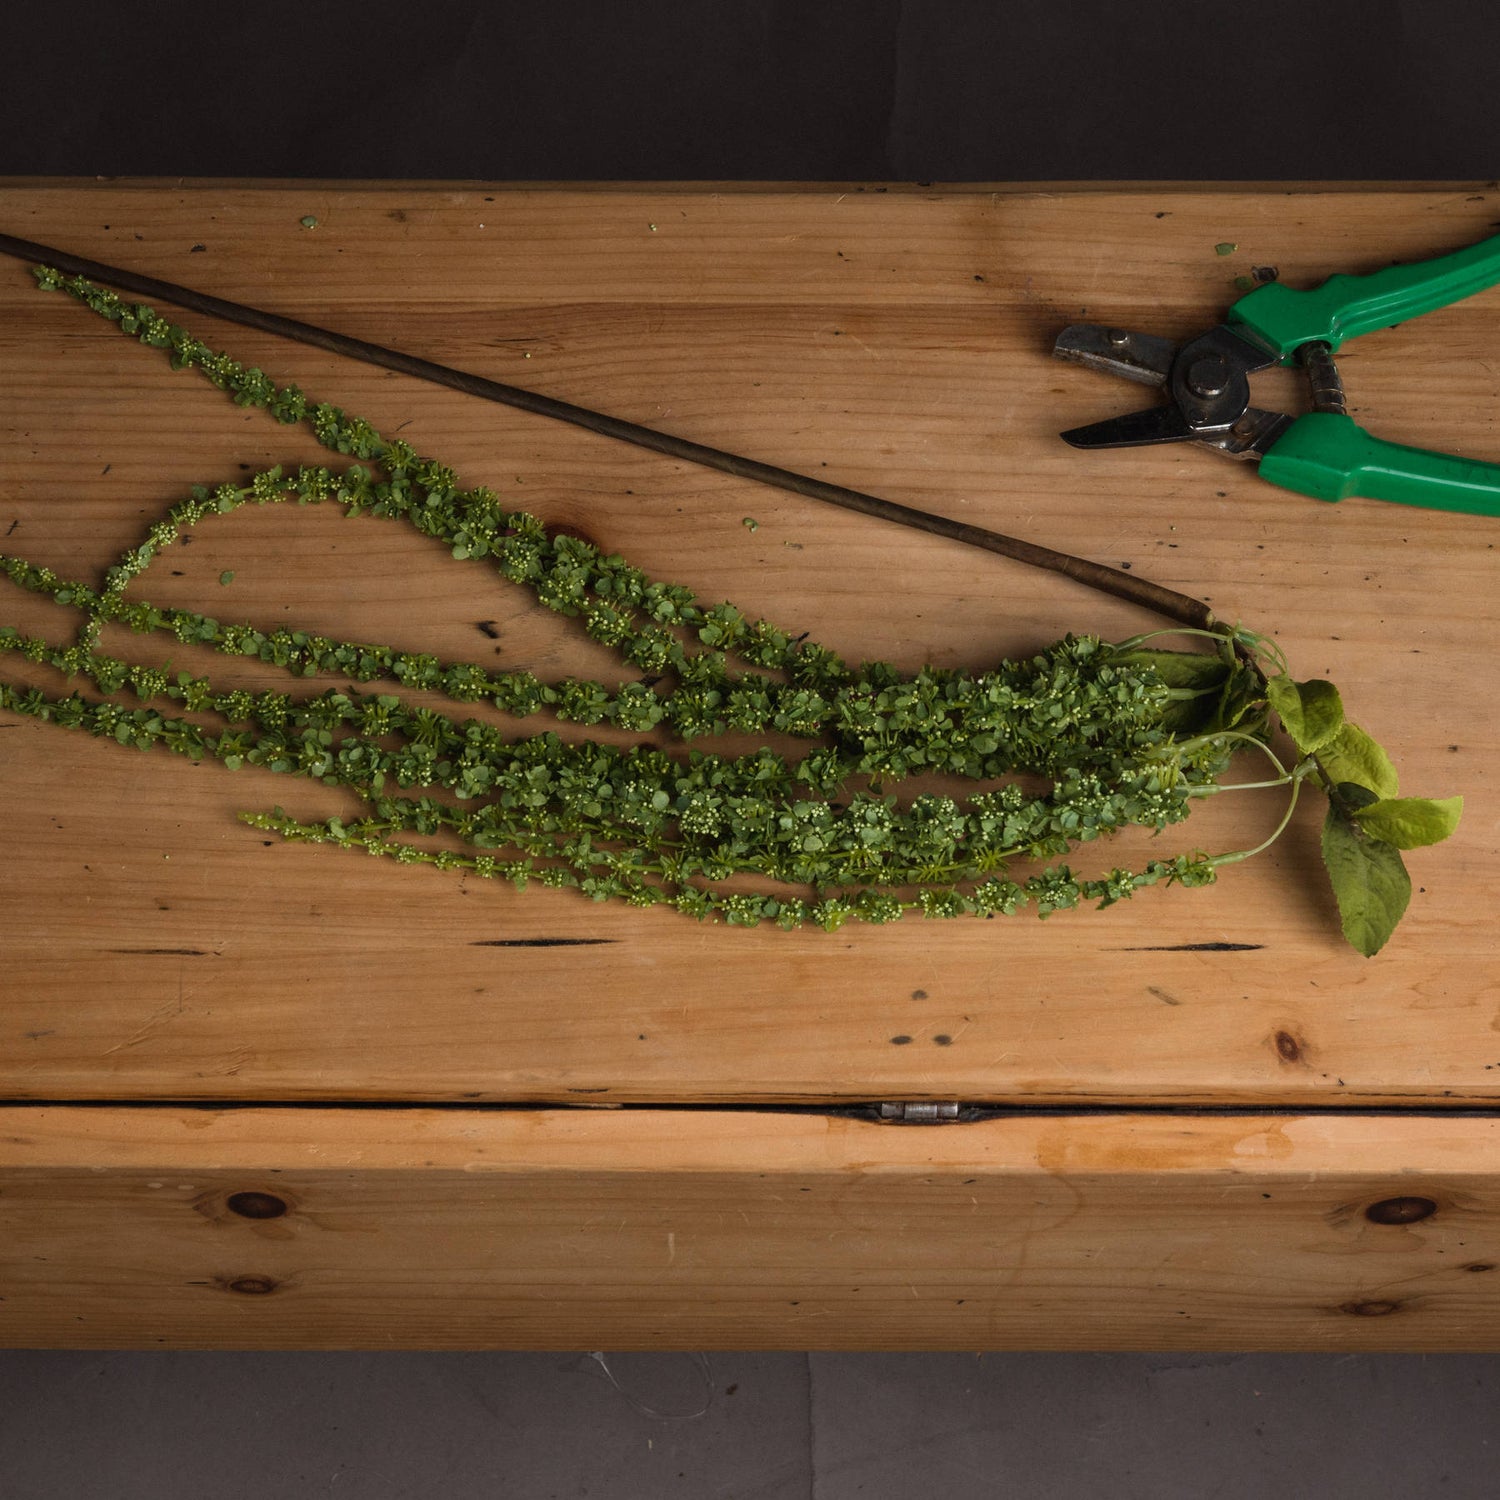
[1260,411,1500,516]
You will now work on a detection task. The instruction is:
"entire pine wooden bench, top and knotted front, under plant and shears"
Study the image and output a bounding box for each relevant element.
[0,182,1500,1350]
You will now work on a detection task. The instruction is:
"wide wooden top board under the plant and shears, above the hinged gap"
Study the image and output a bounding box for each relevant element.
[0,183,1500,1106]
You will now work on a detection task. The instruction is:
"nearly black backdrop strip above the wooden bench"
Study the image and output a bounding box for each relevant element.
[0,0,1500,182]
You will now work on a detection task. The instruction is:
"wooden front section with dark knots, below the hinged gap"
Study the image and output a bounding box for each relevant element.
[0,1107,1500,1352]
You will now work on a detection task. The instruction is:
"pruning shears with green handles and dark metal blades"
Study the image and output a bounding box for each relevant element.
[1053,236,1500,516]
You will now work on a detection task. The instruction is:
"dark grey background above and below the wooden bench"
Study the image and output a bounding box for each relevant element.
[0,0,1500,1500]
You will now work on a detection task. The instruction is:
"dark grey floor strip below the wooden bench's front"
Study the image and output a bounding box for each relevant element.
[0,1352,1500,1500]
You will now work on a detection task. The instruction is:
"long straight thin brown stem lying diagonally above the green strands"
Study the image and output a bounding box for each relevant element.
[0,234,1214,629]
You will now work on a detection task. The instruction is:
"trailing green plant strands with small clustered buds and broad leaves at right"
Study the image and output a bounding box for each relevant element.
[0,269,1460,954]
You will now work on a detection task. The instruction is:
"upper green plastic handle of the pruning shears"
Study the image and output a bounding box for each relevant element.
[1229,234,1500,362]
